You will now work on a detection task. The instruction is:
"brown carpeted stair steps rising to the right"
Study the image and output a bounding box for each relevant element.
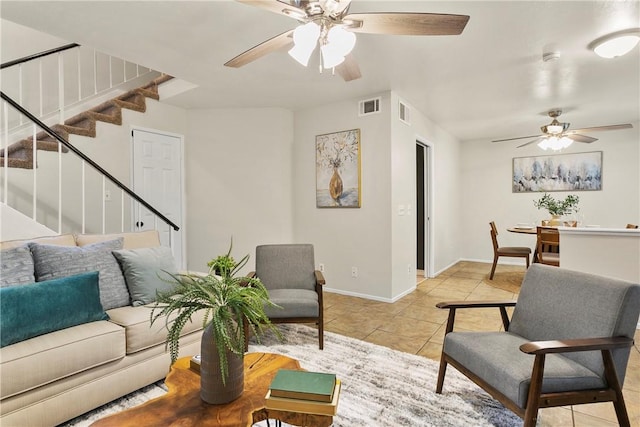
[0,74,173,169]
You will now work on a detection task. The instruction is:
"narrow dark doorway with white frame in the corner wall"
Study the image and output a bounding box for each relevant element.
[416,140,432,277]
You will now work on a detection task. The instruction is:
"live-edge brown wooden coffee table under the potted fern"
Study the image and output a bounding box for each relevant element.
[92,353,333,427]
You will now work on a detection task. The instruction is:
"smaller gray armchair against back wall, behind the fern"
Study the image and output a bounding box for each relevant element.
[249,244,325,350]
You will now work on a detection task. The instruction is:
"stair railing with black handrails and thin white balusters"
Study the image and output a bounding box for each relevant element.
[0,44,180,242]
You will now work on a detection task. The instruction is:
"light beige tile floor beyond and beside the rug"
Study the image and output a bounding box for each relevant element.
[324,262,640,427]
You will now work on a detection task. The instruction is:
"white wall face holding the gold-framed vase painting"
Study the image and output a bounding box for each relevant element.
[293,93,392,299]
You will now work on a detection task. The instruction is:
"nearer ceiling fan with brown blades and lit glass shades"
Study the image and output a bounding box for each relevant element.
[224,0,469,81]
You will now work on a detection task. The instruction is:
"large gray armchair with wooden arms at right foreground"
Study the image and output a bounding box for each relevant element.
[436,264,640,427]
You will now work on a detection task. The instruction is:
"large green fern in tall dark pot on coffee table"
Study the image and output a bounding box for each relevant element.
[151,244,281,404]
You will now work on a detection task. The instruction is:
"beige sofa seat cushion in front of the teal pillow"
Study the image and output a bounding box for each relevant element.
[0,320,125,402]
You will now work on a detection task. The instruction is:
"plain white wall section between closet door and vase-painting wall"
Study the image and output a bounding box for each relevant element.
[185,108,294,272]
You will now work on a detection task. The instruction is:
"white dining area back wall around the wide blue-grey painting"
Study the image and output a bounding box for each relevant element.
[460,122,640,263]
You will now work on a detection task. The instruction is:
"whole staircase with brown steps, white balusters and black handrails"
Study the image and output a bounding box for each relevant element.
[0,44,181,249]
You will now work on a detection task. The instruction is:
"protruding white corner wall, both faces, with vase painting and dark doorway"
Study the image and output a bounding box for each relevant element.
[293,92,461,301]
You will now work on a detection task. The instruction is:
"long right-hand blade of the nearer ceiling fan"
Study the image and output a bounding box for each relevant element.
[343,12,469,36]
